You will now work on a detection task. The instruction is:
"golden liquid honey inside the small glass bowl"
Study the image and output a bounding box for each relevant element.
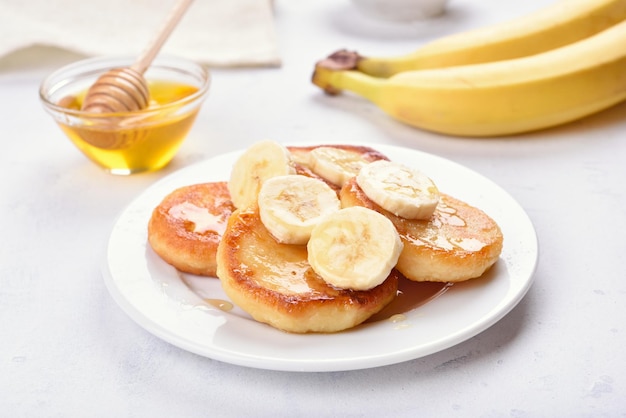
[58,81,198,174]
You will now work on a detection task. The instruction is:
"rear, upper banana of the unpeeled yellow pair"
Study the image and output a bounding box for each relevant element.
[356,0,626,77]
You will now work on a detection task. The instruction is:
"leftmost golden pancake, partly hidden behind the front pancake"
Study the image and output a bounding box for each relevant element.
[148,182,235,277]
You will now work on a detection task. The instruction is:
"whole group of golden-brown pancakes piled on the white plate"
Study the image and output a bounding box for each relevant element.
[148,145,503,333]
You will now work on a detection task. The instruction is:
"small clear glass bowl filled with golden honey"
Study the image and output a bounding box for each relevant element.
[39,56,211,175]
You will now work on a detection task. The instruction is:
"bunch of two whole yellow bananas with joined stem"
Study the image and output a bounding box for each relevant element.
[313,0,626,136]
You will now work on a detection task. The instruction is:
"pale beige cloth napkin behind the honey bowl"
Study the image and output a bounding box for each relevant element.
[0,0,280,66]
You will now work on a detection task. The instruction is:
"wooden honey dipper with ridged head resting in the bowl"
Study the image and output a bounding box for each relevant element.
[81,0,193,113]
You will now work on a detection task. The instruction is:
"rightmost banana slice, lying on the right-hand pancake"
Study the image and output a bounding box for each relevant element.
[356,160,439,219]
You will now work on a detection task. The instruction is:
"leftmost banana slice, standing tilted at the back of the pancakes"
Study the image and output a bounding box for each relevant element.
[228,140,296,208]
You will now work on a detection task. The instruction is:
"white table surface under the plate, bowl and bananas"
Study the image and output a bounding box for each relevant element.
[0,0,626,417]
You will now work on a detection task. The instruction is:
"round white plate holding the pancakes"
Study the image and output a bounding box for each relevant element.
[104,145,537,371]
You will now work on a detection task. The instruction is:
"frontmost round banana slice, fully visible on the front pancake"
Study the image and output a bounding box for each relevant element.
[307,206,403,290]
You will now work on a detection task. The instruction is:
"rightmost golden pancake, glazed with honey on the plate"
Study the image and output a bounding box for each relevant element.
[340,179,503,282]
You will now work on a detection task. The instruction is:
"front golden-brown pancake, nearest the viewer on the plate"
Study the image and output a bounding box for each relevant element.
[217,207,399,333]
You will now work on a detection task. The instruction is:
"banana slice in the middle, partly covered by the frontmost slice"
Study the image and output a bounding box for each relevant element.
[258,174,341,245]
